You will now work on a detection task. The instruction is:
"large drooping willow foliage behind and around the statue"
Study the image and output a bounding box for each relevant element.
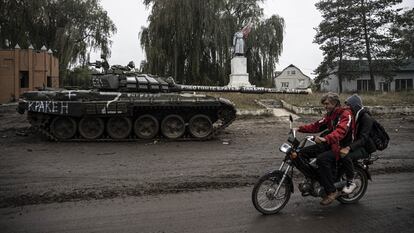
[140,0,283,85]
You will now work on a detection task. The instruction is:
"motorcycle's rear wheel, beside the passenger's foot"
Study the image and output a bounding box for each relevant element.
[337,167,368,204]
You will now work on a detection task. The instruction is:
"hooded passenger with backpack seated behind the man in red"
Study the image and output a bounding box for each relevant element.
[340,94,376,194]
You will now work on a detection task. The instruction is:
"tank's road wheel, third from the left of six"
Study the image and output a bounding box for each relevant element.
[106,117,132,139]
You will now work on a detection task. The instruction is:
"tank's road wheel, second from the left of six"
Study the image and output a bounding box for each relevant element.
[79,117,105,139]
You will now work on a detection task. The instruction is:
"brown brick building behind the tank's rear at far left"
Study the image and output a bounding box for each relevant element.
[0,45,59,104]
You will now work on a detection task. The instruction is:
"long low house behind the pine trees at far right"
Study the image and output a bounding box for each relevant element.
[321,59,414,92]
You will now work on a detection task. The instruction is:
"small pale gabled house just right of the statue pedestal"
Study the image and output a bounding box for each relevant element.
[274,65,312,91]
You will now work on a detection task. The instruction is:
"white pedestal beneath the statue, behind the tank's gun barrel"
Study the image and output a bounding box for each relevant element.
[227,56,254,87]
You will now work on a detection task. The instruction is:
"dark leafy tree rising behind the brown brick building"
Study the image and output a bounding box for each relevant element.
[0,0,116,82]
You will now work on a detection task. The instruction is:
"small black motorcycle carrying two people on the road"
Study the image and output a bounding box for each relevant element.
[252,116,378,215]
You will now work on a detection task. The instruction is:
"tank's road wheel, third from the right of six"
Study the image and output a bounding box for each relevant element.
[134,114,159,139]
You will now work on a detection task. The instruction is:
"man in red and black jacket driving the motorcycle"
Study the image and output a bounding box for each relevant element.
[292,92,352,205]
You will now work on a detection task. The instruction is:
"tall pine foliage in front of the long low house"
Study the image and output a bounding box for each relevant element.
[315,0,406,91]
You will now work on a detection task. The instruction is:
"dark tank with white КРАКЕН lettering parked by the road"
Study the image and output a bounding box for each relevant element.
[17,62,305,141]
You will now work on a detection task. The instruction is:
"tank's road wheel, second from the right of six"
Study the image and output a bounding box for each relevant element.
[161,114,185,139]
